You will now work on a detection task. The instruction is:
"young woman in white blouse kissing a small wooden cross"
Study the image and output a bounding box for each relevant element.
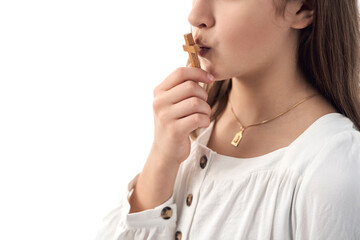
[97,0,360,240]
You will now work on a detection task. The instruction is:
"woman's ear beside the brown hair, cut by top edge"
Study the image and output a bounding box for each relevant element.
[289,0,314,29]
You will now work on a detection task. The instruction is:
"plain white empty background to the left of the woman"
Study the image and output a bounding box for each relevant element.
[0,0,358,240]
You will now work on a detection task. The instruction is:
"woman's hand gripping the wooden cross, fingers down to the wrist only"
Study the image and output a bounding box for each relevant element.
[151,67,214,165]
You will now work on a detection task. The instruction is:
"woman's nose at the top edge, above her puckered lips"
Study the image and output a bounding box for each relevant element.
[188,0,215,28]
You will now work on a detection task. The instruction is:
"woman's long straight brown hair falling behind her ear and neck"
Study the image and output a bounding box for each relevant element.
[188,0,360,137]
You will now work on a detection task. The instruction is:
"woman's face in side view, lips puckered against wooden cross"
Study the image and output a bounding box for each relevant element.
[188,0,297,80]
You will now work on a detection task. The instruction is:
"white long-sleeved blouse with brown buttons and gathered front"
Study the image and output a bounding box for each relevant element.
[96,113,360,240]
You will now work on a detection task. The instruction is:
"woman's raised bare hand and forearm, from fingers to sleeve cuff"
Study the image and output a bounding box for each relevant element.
[129,64,212,213]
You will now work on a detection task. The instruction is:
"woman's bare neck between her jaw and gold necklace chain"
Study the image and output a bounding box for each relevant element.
[229,62,317,126]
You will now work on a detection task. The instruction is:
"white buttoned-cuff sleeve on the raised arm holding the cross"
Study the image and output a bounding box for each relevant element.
[96,174,176,240]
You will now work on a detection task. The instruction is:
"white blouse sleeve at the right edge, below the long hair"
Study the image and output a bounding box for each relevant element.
[294,131,360,240]
